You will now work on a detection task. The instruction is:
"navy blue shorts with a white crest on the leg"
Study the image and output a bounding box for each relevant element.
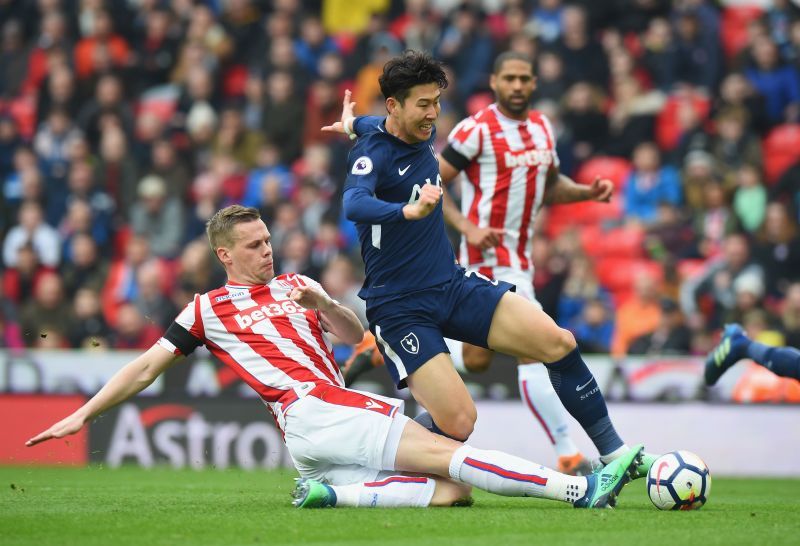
[367,268,515,389]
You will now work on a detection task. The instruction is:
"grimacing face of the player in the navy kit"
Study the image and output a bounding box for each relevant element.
[389,83,442,144]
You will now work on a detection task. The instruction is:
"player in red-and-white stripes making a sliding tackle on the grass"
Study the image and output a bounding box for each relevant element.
[27,205,642,508]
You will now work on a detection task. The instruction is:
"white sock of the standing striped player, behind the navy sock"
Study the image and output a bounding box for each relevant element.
[517,364,579,457]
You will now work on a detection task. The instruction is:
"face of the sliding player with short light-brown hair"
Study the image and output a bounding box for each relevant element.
[222,220,275,284]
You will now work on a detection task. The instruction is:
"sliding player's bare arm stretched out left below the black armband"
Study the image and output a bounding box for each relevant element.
[25,345,177,447]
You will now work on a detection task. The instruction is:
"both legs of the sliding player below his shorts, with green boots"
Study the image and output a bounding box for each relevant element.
[293,416,642,508]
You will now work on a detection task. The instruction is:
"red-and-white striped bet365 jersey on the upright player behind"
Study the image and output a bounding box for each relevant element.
[448,104,559,273]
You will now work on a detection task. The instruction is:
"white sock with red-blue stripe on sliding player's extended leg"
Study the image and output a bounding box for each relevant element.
[450,445,587,503]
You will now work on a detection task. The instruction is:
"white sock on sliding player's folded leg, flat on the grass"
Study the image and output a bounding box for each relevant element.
[329,476,436,508]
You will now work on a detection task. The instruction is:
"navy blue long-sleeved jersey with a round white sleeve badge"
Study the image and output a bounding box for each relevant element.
[344,117,457,299]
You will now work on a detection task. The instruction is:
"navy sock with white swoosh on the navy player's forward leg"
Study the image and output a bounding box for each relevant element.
[545,349,624,455]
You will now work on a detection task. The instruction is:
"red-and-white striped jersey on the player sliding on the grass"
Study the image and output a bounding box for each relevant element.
[159,274,344,409]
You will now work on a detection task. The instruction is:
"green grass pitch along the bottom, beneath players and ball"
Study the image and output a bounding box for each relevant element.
[0,466,800,546]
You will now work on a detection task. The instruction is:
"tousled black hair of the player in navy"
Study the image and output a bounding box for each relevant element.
[378,49,448,104]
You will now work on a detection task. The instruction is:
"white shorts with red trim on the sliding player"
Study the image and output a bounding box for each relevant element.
[283,385,409,485]
